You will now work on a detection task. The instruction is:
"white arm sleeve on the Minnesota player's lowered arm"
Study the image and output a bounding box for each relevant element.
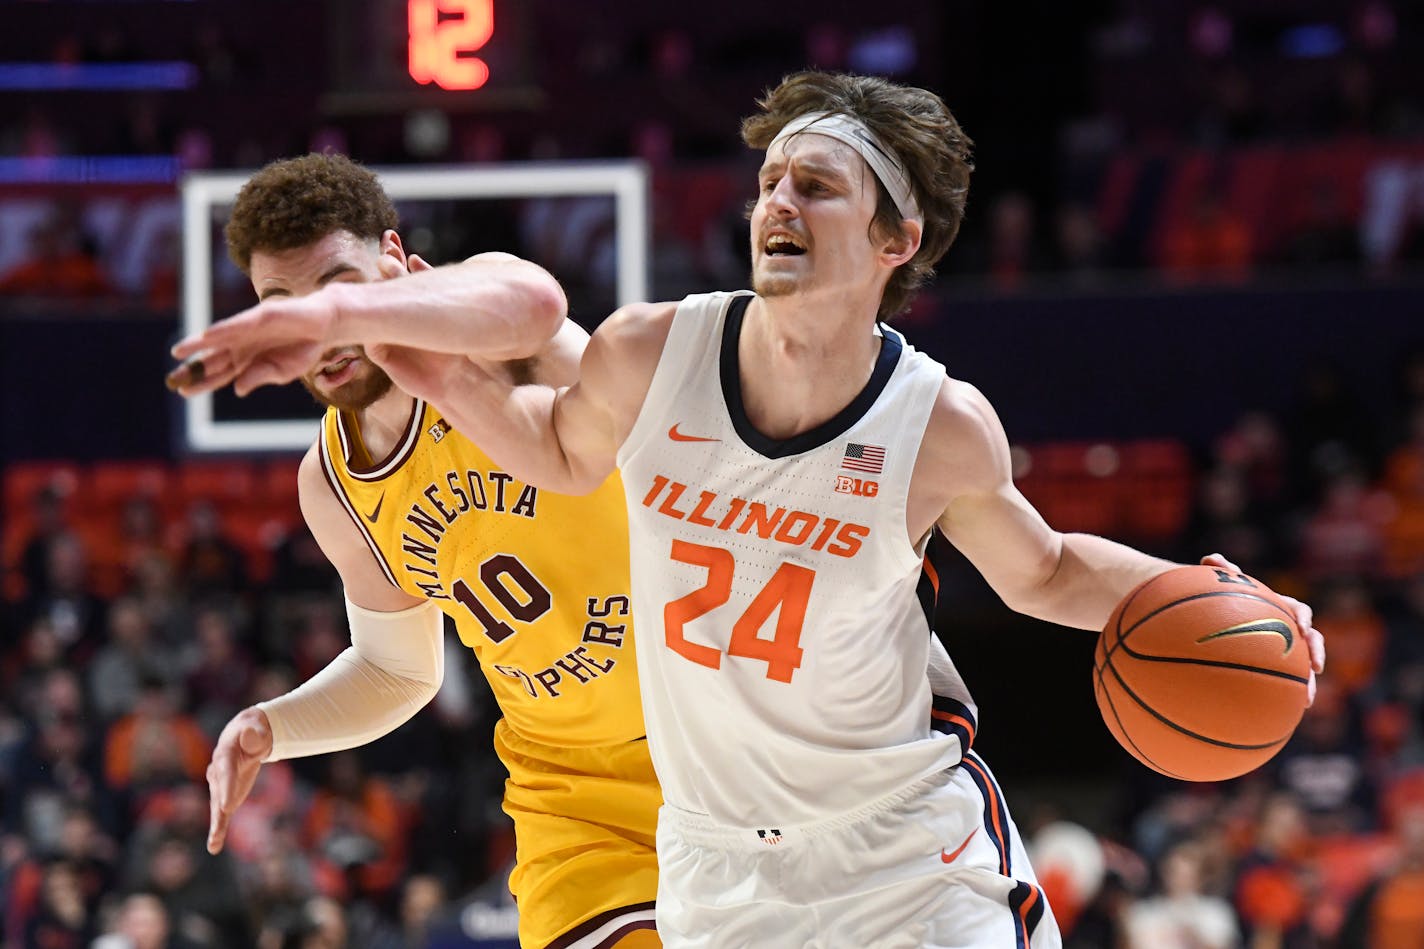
[258,600,444,761]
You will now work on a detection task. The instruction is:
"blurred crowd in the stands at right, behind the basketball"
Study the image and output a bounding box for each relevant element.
[1030,352,1424,949]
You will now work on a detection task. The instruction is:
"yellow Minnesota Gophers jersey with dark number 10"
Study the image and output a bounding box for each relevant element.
[319,399,644,747]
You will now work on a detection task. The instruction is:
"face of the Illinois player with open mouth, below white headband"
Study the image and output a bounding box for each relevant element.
[752,133,883,296]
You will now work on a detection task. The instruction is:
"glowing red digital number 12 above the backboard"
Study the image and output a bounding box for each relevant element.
[406,0,494,90]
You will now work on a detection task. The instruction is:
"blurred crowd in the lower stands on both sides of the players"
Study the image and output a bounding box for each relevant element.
[0,351,1424,949]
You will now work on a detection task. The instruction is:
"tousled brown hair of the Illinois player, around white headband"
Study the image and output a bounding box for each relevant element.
[742,70,974,319]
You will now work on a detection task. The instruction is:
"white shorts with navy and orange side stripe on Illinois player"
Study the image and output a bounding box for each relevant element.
[658,752,1062,949]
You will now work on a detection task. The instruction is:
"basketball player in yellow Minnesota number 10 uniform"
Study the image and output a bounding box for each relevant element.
[169,155,661,949]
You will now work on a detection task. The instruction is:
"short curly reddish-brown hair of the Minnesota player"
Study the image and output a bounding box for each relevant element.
[224,154,400,274]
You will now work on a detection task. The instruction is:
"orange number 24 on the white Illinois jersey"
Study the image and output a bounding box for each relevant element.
[662,540,816,683]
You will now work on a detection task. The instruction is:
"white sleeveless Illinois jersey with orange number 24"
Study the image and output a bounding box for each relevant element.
[618,292,975,828]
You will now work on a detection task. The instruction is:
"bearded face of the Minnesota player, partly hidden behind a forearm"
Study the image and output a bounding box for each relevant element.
[249,231,403,412]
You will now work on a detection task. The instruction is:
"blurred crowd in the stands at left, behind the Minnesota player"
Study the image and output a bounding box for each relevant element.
[0,463,513,949]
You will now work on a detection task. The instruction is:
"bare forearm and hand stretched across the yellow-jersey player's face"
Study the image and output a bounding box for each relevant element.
[169,254,567,396]
